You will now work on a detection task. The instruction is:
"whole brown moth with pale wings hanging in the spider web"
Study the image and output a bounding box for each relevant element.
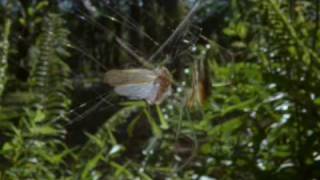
[104,67,172,104]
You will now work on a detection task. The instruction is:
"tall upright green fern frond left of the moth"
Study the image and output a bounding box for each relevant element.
[30,14,71,125]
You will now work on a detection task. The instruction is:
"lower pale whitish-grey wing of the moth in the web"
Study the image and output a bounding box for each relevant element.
[114,82,159,103]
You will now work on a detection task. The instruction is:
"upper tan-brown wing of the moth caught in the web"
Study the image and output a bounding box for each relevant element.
[104,69,157,86]
